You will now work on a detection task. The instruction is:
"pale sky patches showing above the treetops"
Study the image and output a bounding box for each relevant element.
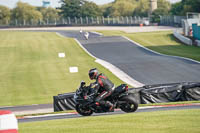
[0,0,180,8]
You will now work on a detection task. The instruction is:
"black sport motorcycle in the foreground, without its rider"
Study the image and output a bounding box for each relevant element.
[74,81,138,116]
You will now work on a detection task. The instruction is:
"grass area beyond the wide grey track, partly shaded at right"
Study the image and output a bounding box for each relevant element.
[97,31,200,61]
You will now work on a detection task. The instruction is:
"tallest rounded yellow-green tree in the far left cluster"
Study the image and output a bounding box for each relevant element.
[12,2,42,24]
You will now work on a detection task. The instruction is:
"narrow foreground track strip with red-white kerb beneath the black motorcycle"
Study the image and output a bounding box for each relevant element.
[18,104,200,123]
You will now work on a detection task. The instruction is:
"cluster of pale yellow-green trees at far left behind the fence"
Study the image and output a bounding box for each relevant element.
[0,2,60,24]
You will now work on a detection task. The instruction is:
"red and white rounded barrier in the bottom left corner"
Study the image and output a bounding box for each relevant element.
[0,110,18,133]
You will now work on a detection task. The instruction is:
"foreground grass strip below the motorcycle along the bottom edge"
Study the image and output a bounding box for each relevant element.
[19,109,200,133]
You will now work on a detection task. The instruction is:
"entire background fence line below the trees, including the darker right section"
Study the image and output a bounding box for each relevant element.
[0,16,186,27]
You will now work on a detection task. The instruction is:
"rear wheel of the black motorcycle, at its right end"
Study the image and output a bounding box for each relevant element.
[120,95,138,113]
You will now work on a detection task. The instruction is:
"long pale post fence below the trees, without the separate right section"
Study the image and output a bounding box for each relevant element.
[0,16,149,27]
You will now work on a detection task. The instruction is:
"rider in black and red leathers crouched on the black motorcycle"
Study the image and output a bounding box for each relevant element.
[89,68,115,111]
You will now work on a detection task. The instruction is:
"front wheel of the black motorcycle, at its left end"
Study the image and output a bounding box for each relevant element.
[76,104,93,116]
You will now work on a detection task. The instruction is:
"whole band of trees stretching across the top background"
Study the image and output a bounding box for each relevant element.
[0,0,200,24]
